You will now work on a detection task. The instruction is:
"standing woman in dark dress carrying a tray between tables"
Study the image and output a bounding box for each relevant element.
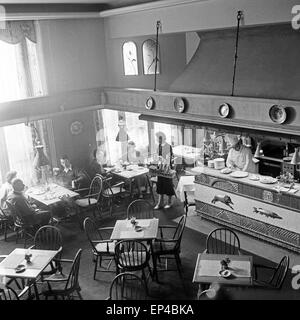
[154,132,175,210]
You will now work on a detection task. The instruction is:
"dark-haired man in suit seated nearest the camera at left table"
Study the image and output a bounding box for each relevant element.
[7,178,51,227]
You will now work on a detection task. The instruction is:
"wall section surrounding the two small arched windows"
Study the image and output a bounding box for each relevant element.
[106,33,186,90]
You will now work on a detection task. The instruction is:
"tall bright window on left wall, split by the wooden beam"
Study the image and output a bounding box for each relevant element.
[0,21,43,185]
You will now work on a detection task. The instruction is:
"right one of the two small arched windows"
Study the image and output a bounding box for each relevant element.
[143,39,160,74]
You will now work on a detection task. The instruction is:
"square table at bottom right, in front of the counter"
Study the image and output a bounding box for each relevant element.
[193,253,253,298]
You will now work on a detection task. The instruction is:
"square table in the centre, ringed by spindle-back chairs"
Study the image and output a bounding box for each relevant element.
[110,218,159,275]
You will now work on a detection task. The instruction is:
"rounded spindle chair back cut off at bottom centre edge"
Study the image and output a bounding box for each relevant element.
[109,272,147,300]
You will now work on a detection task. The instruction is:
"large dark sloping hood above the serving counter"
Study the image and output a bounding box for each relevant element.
[170,24,300,100]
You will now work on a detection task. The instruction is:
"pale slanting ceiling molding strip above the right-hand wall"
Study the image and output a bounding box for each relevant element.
[100,0,205,18]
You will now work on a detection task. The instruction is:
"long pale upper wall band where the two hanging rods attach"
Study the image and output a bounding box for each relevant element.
[101,0,299,38]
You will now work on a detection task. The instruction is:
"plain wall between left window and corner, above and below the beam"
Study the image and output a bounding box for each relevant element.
[38,19,107,166]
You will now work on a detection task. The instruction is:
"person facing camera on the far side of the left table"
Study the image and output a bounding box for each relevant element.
[57,155,89,189]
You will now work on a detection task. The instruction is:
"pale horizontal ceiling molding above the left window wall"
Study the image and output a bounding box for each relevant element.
[0,12,100,21]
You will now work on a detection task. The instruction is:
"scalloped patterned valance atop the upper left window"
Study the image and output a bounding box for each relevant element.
[0,21,36,44]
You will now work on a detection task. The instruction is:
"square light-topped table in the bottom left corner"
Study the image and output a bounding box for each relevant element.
[0,248,58,299]
